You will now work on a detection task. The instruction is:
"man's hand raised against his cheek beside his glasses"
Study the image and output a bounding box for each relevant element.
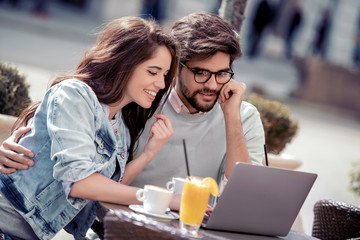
[219,79,246,118]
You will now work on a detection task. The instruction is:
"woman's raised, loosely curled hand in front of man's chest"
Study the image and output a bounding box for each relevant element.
[144,113,174,160]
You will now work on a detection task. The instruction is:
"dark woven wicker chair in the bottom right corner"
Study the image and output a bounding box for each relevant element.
[312,200,360,240]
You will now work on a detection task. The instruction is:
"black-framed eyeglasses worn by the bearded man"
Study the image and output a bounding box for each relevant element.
[180,63,234,84]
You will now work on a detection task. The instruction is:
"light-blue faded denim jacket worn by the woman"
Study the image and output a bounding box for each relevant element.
[0,79,130,239]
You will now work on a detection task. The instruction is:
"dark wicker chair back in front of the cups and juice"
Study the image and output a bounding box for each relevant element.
[104,209,188,240]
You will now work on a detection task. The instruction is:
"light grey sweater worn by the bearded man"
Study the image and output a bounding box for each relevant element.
[131,100,265,188]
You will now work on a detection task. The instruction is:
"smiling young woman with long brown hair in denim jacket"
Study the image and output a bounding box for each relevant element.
[0,17,179,239]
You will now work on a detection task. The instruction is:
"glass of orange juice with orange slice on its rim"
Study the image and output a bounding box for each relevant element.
[180,177,219,237]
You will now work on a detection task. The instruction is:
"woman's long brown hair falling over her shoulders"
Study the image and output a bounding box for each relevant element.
[13,17,179,161]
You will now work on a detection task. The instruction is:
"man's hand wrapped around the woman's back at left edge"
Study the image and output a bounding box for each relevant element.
[0,127,34,174]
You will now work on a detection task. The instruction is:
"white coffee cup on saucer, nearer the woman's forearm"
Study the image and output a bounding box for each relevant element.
[136,185,173,214]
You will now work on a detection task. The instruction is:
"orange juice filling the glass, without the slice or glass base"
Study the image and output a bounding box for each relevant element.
[180,177,210,226]
